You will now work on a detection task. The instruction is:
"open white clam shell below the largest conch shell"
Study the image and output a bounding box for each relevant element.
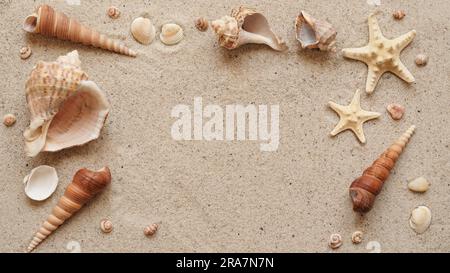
[23,165,58,201]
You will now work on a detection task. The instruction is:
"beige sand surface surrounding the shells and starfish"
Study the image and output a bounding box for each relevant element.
[0,0,450,252]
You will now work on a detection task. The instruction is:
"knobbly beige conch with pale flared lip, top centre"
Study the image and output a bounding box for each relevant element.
[211,7,287,51]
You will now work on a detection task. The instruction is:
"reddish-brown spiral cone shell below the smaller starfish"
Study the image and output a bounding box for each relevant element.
[350,125,416,213]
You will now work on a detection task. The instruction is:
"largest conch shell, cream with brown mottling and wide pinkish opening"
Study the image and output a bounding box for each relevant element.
[24,50,110,156]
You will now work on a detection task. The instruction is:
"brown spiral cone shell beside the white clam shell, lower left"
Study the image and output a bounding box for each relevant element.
[27,167,111,252]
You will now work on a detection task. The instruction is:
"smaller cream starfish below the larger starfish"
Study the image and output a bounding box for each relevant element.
[328,90,381,143]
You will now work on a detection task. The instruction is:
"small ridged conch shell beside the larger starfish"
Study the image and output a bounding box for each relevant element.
[295,11,337,52]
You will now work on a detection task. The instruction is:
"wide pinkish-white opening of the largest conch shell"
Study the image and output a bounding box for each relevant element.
[43,81,109,152]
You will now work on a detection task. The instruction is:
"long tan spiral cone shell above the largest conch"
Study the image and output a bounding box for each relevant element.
[23,5,136,57]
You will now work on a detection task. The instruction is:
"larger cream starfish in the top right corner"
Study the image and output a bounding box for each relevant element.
[342,14,416,93]
